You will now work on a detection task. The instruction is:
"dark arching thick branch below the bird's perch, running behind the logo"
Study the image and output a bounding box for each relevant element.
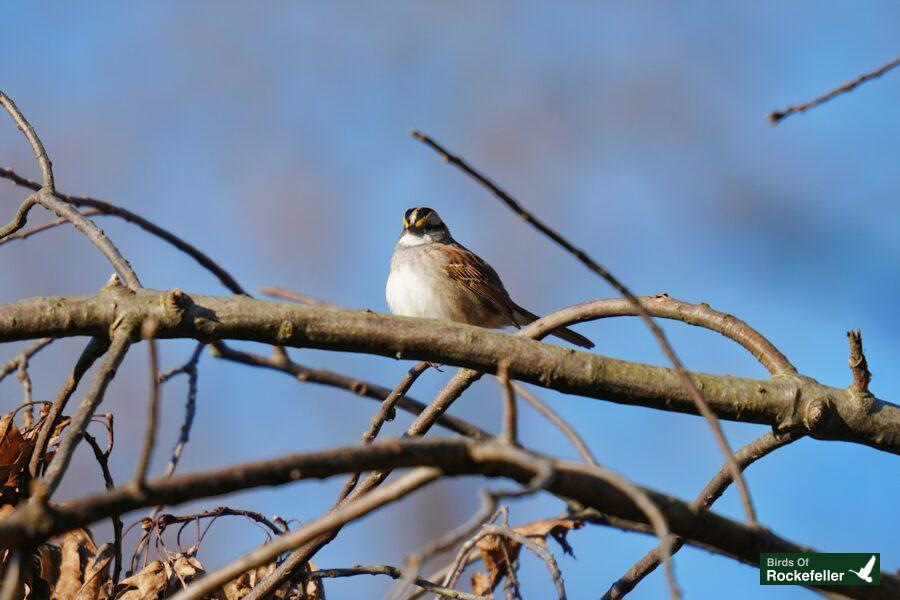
[0,438,900,598]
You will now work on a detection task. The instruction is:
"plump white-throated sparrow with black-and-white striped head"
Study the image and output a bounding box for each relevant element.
[385,206,594,348]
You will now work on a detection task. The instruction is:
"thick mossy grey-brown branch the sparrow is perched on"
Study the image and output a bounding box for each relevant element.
[0,285,900,454]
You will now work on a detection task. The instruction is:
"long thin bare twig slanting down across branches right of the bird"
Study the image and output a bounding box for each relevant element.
[412,131,756,523]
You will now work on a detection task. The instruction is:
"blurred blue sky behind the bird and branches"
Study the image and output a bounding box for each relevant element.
[0,2,900,598]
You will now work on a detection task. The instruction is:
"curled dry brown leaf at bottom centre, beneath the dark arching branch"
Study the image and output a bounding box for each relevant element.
[472,518,584,595]
